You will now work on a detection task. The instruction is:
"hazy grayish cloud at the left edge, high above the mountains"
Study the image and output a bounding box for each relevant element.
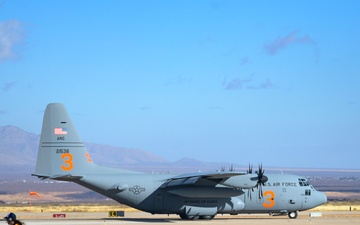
[0,20,24,63]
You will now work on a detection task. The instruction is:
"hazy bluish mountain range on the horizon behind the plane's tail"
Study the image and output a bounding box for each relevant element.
[0,126,228,174]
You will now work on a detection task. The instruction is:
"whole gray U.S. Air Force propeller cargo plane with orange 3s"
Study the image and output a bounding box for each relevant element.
[32,103,327,220]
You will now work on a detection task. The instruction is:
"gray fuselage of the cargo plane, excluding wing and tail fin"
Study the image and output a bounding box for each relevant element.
[76,171,326,214]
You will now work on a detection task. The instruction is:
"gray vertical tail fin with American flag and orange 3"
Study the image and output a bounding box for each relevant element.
[33,103,96,178]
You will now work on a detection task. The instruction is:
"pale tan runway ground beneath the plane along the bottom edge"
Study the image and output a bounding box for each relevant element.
[7,211,360,225]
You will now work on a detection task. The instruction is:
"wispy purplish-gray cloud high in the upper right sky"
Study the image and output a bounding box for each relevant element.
[264,31,316,55]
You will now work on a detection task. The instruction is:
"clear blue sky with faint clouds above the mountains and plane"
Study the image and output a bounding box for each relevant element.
[0,0,360,169]
